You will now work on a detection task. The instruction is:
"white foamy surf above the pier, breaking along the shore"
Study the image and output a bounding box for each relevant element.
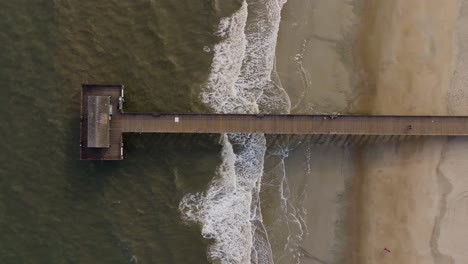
[201,0,290,113]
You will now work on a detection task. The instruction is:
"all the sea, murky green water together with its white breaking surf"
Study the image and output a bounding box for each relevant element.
[0,0,308,263]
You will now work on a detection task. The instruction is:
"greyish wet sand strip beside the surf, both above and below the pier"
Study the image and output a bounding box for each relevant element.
[276,0,363,264]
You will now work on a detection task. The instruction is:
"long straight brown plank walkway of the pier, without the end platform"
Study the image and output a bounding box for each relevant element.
[120,114,468,136]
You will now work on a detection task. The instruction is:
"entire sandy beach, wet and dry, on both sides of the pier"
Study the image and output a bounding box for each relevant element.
[277,0,468,264]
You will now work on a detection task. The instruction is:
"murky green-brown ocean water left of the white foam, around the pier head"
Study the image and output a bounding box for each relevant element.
[0,0,240,263]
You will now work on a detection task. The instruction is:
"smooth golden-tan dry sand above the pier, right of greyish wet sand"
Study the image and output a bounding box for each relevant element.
[354,0,459,115]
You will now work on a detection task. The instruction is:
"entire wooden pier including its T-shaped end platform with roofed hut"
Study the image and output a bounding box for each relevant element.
[80,84,468,160]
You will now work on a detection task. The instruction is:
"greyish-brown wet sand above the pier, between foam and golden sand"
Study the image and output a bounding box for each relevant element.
[276,0,359,113]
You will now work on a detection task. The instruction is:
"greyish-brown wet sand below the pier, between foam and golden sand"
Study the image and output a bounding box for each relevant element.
[286,144,353,264]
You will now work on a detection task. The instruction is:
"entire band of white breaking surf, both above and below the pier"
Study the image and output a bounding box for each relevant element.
[179,0,289,263]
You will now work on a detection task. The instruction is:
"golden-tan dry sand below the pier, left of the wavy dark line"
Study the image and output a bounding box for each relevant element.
[348,139,444,263]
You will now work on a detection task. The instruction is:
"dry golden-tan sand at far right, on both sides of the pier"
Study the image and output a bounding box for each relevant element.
[349,0,468,264]
